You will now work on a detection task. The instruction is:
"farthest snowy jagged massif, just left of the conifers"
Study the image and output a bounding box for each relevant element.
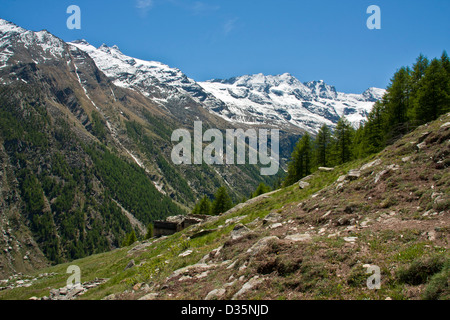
[200,73,385,133]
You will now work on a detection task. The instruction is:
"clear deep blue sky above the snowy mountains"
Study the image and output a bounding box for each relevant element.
[0,0,450,93]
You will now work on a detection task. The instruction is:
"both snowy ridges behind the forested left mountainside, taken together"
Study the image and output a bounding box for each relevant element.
[71,40,385,134]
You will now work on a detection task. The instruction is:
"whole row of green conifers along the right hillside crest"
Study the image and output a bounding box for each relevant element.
[283,51,450,186]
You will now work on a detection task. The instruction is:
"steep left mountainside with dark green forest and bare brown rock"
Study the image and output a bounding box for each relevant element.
[0,19,282,276]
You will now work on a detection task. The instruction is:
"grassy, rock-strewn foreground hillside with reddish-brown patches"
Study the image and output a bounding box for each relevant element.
[0,114,450,300]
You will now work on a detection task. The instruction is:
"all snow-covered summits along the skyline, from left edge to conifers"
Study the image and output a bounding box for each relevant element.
[0,19,385,134]
